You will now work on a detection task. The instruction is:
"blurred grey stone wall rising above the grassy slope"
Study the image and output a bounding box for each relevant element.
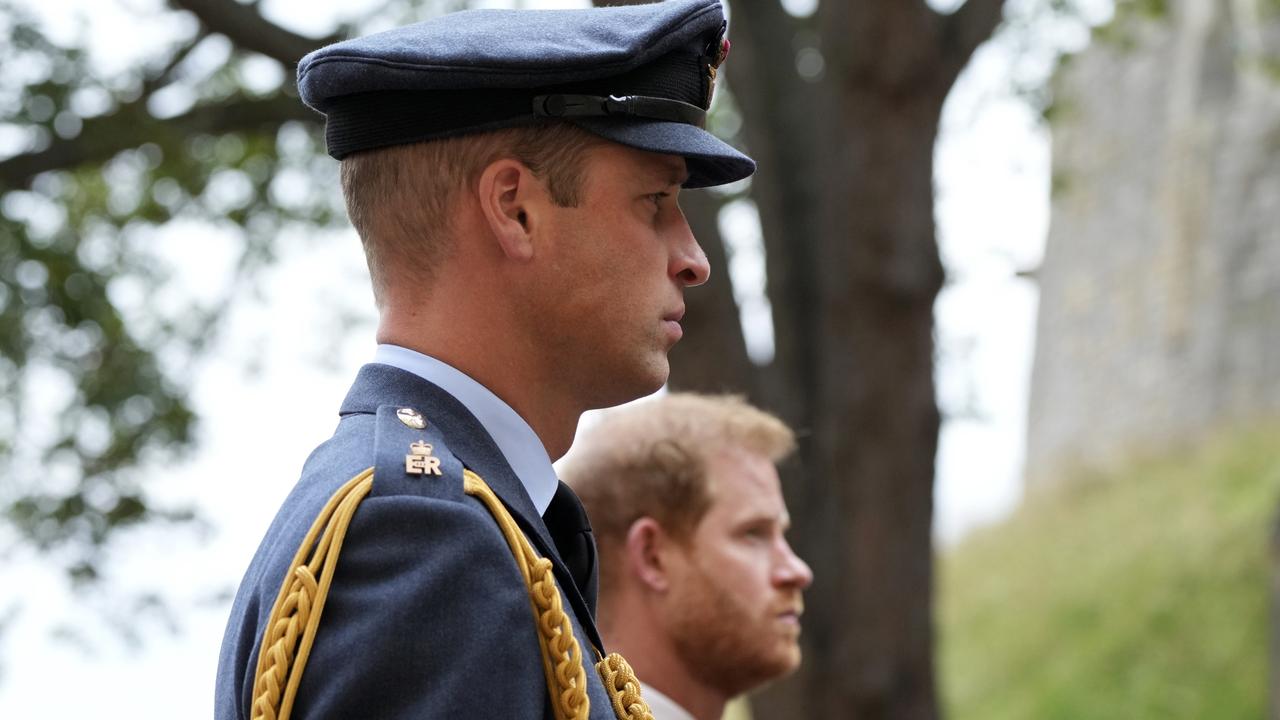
[1027,0,1280,486]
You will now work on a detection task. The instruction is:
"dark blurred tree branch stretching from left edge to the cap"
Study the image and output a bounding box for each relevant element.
[0,92,320,190]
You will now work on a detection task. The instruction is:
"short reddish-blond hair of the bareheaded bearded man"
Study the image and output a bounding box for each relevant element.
[561,393,796,548]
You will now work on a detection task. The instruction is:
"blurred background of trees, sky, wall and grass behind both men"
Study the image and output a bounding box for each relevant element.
[0,0,1280,720]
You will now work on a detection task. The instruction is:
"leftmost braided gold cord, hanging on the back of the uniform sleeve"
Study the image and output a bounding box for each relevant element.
[251,468,374,720]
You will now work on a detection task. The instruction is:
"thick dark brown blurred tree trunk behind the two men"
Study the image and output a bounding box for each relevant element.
[672,0,1004,720]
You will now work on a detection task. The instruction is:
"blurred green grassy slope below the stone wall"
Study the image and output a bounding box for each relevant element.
[938,427,1280,720]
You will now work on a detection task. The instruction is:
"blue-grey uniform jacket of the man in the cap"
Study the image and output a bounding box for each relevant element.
[215,365,613,720]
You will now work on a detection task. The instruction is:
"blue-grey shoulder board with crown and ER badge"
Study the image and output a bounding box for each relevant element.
[372,405,466,501]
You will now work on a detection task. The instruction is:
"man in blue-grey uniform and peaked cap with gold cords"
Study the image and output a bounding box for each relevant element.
[215,0,754,720]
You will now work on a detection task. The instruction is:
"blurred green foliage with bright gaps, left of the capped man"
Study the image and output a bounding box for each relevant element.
[0,1,340,583]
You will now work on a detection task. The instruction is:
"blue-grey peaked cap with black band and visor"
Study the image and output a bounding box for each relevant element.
[298,0,755,187]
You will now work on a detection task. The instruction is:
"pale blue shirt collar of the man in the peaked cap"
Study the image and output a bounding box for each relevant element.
[374,345,559,515]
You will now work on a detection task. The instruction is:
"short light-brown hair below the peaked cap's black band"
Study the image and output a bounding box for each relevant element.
[339,122,607,306]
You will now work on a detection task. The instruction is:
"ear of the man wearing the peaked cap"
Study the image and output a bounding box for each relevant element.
[477,158,545,260]
